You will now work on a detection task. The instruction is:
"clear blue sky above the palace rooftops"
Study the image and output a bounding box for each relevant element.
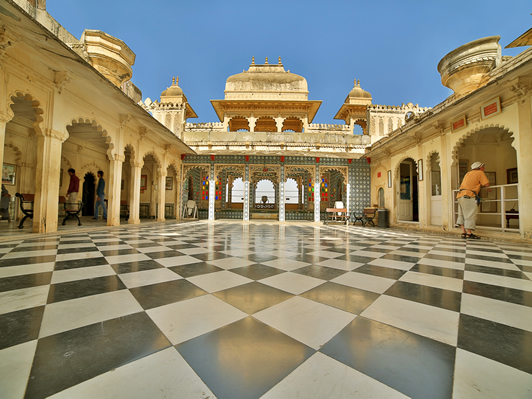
[47,0,532,123]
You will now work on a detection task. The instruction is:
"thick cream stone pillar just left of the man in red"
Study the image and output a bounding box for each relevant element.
[33,130,68,233]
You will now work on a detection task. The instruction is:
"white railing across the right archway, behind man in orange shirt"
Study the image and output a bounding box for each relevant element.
[453,183,519,233]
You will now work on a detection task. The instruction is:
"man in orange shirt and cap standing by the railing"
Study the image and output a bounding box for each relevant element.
[456,162,491,239]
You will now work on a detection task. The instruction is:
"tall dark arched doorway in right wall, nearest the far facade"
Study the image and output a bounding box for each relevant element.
[397,158,419,222]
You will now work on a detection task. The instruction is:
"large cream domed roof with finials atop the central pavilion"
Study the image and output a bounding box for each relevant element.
[225,57,308,100]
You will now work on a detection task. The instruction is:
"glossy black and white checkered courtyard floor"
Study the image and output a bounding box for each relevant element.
[0,222,532,399]
